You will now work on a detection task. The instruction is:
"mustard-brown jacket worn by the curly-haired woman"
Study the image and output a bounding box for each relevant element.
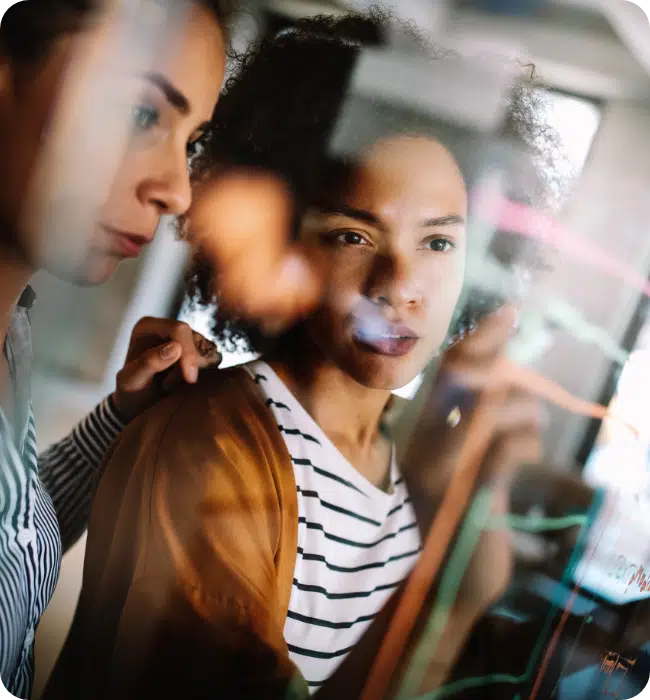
[45,369,308,700]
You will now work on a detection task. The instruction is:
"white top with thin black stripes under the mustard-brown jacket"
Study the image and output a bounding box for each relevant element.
[245,361,421,692]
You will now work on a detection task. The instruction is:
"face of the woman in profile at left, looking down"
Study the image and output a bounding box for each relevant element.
[0,4,225,284]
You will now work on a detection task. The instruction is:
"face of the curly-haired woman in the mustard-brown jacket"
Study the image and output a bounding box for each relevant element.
[301,136,467,389]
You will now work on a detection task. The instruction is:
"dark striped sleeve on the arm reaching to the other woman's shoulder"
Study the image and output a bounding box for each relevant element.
[38,396,126,552]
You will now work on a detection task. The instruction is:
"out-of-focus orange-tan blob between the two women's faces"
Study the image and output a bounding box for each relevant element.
[189,173,321,332]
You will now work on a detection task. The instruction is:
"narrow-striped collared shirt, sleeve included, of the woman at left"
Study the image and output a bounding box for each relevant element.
[0,289,124,700]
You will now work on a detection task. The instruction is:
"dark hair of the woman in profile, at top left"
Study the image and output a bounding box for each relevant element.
[0,0,237,63]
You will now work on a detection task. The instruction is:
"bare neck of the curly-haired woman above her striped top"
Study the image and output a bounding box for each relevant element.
[268,332,390,457]
